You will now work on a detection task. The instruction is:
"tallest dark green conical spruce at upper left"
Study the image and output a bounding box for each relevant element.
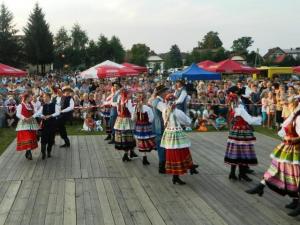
[24,4,54,74]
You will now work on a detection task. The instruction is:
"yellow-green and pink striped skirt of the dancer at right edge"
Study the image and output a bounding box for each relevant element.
[264,137,300,197]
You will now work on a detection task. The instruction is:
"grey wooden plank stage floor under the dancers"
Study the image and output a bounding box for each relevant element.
[0,132,300,225]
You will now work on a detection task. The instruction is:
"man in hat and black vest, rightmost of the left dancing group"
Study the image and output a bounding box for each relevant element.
[58,86,74,148]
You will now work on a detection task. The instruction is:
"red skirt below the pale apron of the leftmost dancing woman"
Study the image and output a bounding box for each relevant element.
[17,130,38,151]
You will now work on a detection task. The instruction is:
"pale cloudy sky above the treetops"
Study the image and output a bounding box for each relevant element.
[0,0,300,54]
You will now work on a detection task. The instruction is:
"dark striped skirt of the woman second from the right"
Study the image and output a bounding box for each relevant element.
[224,129,257,166]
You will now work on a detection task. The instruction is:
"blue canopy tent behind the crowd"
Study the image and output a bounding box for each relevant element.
[170,63,221,81]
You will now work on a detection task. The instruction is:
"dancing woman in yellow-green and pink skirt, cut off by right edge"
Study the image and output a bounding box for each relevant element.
[246,99,300,216]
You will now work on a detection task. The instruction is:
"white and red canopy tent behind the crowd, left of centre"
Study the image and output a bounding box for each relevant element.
[80,60,139,79]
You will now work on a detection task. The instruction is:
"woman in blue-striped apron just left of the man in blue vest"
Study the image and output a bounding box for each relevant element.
[132,93,156,165]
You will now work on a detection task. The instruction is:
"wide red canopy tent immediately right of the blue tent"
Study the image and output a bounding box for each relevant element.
[206,59,260,74]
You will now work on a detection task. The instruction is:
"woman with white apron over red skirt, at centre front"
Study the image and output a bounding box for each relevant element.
[161,94,198,185]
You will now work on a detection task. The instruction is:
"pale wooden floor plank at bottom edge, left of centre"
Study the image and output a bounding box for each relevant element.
[63,179,77,225]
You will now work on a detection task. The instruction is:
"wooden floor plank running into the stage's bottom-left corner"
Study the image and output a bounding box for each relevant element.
[0,181,22,225]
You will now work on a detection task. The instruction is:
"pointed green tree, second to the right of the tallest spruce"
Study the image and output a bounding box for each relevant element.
[70,24,89,69]
